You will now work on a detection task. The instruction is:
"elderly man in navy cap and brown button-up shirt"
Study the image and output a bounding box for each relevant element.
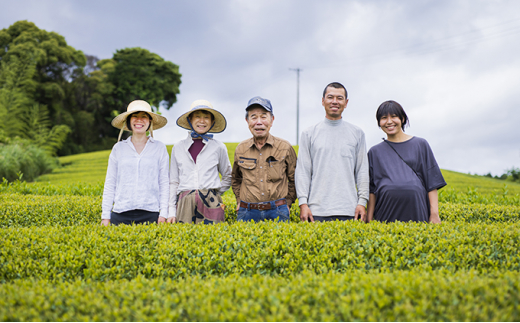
[231,97,296,222]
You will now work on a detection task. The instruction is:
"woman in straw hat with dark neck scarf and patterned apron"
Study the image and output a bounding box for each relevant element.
[168,100,231,224]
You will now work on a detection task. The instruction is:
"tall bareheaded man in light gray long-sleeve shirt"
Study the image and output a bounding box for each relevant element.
[295,82,369,222]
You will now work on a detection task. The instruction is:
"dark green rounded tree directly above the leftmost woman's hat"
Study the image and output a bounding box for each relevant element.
[98,47,181,111]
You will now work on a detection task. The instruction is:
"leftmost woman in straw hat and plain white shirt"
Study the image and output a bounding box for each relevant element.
[101,100,169,225]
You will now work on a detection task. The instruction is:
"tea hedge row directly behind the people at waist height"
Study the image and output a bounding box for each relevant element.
[0,193,520,228]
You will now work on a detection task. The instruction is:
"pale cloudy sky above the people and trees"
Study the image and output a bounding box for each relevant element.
[0,0,520,175]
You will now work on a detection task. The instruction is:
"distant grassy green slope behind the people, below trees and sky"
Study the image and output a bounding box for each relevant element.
[38,143,520,195]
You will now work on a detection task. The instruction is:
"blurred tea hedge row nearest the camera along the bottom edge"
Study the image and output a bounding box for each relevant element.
[0,271,520,322]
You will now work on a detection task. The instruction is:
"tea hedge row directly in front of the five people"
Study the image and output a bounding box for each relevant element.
[0,222,520,283]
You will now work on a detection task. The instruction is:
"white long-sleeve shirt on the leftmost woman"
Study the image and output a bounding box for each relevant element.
[101,137,170,219]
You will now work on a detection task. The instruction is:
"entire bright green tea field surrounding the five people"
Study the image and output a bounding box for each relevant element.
[0,144,520,321]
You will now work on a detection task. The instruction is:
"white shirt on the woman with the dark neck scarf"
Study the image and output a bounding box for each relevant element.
[169,135,231,217]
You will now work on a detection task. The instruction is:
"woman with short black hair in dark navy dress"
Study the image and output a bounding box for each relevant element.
[368,101,446,223]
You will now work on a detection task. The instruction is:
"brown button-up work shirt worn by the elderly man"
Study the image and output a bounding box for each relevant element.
[231,134,296,207]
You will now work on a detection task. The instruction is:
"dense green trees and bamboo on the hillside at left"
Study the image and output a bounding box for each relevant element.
[0,20,181,180]
